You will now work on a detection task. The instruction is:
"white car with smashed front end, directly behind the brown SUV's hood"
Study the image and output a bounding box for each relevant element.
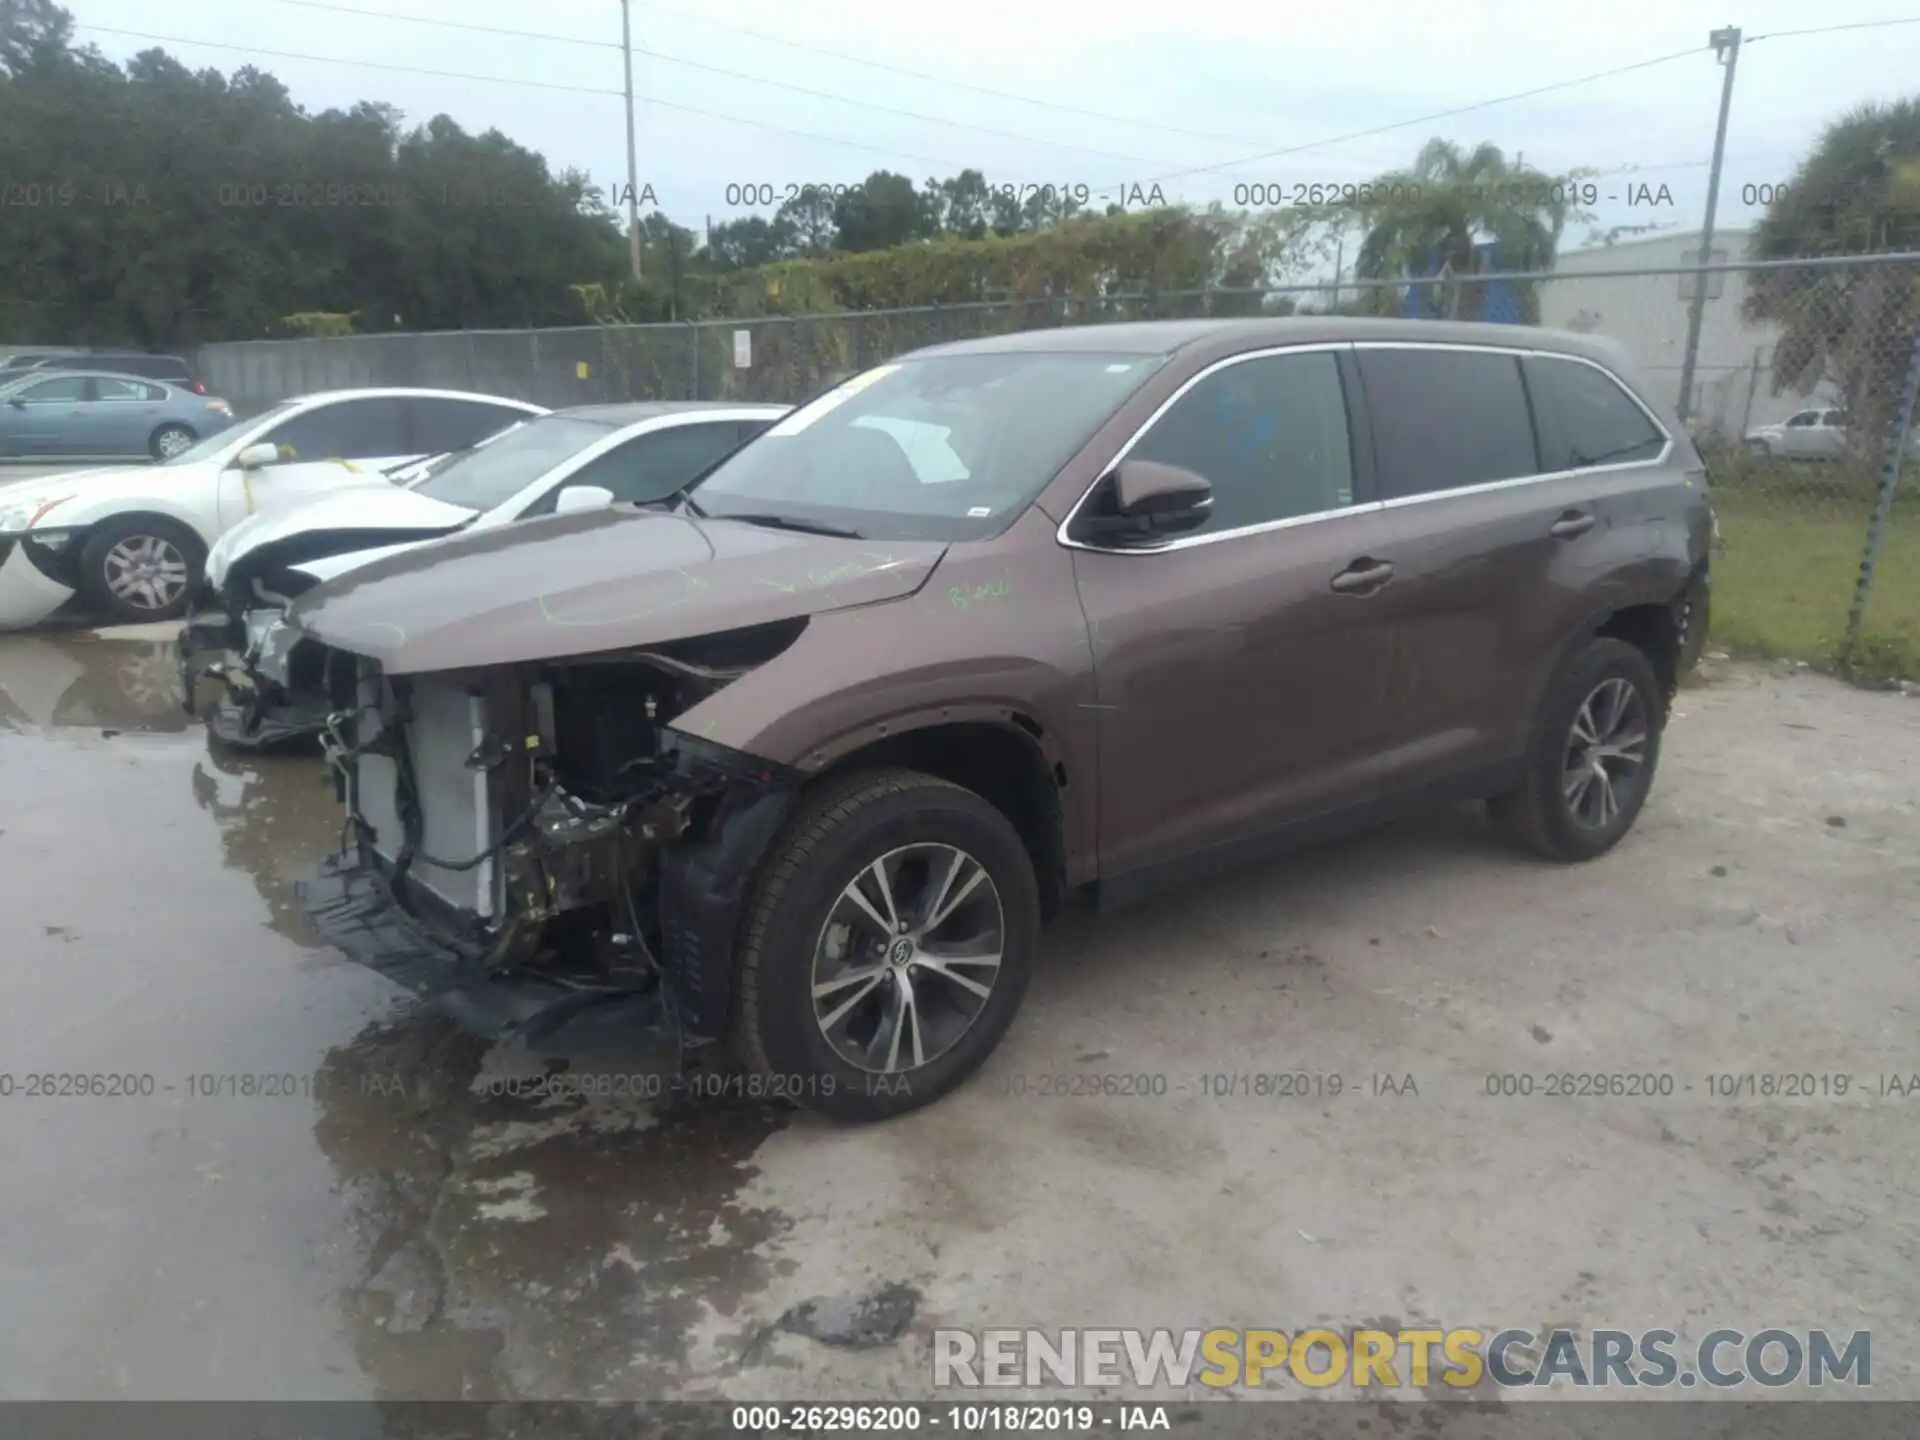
[179,401,789,747]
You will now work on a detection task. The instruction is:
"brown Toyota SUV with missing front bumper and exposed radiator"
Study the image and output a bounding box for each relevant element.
[280,319,1713,1119]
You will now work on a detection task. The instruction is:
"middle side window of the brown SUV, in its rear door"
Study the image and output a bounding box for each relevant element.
[1359,348,1540,499]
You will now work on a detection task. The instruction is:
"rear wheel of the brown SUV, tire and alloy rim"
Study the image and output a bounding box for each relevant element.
[1488,637,1667,860]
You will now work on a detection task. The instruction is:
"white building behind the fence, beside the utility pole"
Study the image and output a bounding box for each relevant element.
[1540,230,1836,438]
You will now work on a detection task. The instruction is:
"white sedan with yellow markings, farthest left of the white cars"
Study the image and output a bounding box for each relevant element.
[0,390,545,630]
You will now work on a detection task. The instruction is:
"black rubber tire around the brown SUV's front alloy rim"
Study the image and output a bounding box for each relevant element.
[733,770,1041,1121]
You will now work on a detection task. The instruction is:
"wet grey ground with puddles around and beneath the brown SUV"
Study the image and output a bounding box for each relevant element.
[0,632,1920,1400]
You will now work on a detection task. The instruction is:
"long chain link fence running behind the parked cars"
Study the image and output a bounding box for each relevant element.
[200,250,1920,678]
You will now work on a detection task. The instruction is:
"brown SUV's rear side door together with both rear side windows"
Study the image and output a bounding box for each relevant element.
[1357,342,1668,791]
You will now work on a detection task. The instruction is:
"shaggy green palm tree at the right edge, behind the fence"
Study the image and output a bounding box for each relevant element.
[1745,98,1920,459]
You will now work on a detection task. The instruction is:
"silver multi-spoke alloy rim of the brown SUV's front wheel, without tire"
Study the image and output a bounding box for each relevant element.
[810,843,1006,1075]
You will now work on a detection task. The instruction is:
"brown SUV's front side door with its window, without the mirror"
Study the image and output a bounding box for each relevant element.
[1068,346,1392,876]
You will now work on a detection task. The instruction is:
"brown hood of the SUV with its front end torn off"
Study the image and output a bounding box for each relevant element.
[288,509,947,674]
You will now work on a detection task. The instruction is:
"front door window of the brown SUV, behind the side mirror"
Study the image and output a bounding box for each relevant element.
[1127,349,1354,540]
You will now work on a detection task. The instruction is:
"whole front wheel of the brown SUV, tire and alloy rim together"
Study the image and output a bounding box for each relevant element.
[735,770,1041,1121]
